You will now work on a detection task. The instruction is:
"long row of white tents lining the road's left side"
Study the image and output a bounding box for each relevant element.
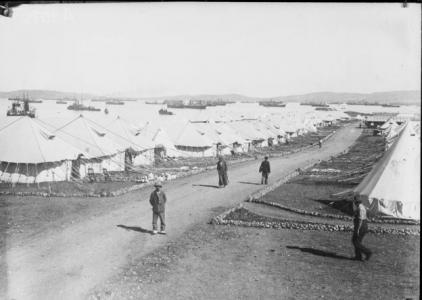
[0,110,346,183]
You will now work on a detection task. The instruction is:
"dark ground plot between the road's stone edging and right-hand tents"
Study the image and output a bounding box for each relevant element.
[262,132,385,215]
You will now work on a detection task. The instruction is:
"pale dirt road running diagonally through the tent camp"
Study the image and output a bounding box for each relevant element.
[6,126,360,300]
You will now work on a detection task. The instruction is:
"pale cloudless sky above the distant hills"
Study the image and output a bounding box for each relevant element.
[0,2,421,97]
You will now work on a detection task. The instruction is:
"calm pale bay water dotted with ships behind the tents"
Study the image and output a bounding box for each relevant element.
[0,99,420,129]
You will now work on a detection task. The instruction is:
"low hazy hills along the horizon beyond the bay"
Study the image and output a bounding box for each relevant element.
[0,90,421,105]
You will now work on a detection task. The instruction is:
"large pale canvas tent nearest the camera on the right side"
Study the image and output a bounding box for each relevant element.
[354,125,421,220]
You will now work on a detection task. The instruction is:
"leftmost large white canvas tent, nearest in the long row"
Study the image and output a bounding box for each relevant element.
[0,117,86,183]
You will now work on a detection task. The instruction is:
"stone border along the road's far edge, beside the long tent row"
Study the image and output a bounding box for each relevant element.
[0,130,336,198]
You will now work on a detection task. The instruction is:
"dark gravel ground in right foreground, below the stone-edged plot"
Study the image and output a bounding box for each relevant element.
[89,224,420,299]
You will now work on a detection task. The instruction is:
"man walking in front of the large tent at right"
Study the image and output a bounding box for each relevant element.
[352,196,372,261]
